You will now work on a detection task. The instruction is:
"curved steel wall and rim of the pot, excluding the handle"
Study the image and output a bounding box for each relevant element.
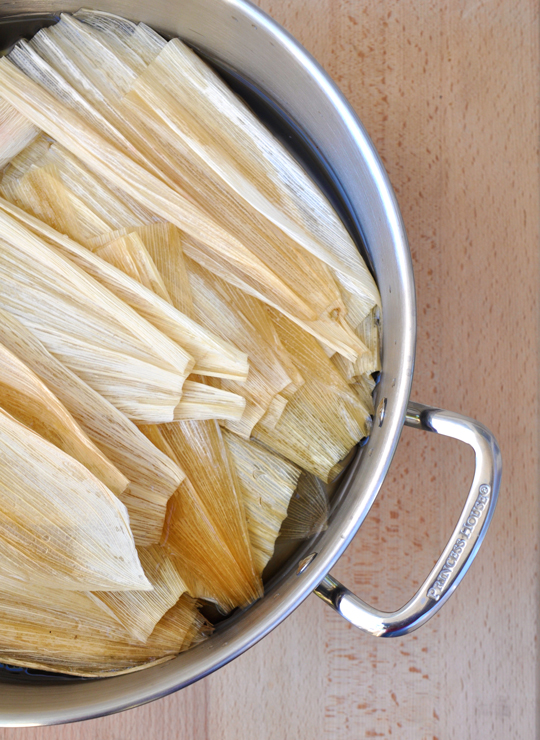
[0,0,416,726]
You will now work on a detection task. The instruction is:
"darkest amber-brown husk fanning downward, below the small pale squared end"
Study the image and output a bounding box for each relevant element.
[143,421,262,611]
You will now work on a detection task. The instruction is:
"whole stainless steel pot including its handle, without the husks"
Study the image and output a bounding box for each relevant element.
[0,0,501,726]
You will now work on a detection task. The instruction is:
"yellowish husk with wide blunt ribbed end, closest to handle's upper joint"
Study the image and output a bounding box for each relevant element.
[253,311,370,483]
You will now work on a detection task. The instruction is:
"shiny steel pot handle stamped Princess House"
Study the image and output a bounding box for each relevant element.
[315,402,502,637]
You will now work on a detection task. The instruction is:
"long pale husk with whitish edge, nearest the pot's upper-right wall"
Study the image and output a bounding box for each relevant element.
[126,39,380,315]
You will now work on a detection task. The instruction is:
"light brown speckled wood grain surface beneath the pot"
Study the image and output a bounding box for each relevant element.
[0,0,540,740]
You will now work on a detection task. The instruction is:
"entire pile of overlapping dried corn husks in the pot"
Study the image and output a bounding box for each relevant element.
[0,10,380,676]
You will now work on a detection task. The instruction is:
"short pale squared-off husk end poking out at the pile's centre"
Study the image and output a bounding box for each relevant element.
[174,376,246,423]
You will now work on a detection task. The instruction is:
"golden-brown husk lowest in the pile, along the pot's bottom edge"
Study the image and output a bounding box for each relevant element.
[0,596,210,677]
